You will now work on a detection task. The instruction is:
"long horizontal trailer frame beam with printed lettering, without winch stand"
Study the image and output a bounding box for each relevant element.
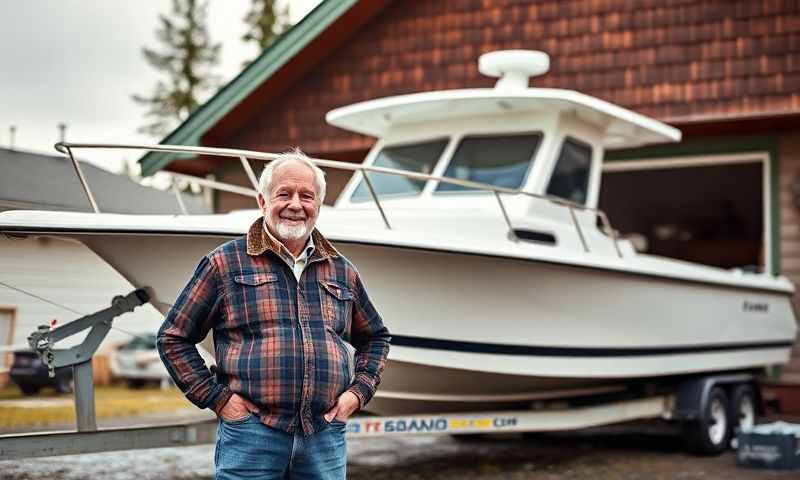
[0,396,672,460]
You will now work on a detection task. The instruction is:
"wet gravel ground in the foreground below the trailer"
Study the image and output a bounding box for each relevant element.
[0,427,800,480]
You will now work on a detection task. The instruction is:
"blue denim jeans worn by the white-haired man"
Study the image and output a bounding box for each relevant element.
[214,415,347,480]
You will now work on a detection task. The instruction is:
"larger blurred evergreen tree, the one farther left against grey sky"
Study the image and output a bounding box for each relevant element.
[133,0,221,137]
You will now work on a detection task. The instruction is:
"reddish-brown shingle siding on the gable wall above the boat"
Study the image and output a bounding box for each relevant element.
[225,0,800,153]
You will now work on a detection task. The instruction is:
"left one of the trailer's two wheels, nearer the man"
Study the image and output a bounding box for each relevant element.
[684,387,732,455]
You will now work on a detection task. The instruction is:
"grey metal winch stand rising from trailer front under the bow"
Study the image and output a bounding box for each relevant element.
[28,288,150,432]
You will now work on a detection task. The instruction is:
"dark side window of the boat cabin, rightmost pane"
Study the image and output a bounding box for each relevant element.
[547,137,592,205]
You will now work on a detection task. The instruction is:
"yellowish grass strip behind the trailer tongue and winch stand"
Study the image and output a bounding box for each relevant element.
[0,387,194,430]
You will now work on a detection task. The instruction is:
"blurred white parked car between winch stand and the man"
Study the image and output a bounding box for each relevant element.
[109,333,214,388]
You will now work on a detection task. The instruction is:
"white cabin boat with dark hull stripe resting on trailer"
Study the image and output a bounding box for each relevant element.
[0,51,796,414]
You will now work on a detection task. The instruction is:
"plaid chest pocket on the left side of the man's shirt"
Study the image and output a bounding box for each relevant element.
[228,273,288,326]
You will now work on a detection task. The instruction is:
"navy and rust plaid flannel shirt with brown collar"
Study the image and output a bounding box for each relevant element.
[157,218,390,435]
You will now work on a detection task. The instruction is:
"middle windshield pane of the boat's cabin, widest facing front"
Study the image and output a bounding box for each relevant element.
[436,133,542,192]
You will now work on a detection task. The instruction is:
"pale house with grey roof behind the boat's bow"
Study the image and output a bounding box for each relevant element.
[0,149,209,386]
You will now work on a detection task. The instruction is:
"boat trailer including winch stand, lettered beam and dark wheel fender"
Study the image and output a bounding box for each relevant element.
[0,289,760,460]
